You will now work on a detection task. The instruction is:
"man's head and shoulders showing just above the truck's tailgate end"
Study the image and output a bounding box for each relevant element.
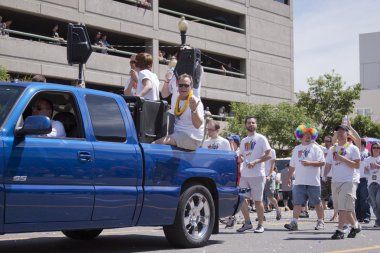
[202,120,231,151]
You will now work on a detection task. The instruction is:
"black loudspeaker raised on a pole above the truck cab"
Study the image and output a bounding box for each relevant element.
[67,23,92,65]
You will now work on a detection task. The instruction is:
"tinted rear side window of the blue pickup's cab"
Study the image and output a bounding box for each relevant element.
[86,95,127,142]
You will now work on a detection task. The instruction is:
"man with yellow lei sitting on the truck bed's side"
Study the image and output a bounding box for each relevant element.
[153,74,204,150]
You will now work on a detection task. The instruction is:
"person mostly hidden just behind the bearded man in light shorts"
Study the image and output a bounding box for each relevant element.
[263,149,281,220]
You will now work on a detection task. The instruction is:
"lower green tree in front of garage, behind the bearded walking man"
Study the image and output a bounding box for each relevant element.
[227,102,311,157]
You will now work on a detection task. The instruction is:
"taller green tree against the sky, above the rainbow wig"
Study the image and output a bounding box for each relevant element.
[296,71,361,137]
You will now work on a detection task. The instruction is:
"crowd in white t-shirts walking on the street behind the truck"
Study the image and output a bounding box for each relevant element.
[203,117,380,239]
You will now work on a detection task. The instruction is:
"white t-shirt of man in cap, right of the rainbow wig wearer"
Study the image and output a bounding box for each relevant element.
[326,144,360,183]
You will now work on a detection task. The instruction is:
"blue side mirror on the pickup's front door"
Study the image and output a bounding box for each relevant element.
[15,116,52,136]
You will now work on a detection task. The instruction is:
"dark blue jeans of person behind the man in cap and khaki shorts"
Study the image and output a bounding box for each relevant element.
[355,177,371,220]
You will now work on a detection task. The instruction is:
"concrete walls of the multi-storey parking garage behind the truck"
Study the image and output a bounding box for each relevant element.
[0,0,294,112]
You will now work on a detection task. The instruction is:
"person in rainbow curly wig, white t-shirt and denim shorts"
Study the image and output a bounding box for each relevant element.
[284,124,325,230]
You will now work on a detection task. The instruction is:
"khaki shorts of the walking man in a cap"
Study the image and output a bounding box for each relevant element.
[331,182,358,212]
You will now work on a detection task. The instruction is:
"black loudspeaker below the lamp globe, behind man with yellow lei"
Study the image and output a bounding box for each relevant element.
[174,48,202,89]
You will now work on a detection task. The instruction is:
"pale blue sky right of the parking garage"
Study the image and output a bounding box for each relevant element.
[293,0,380,92]
